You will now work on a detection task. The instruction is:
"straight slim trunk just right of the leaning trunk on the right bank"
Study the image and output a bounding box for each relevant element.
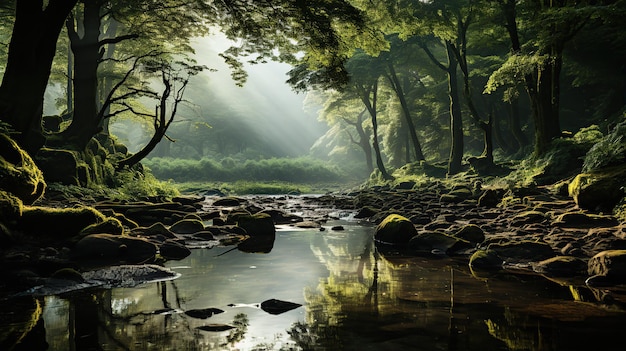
[446,41,463,175]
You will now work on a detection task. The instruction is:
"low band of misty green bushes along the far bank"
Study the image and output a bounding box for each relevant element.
[143,157,348,183]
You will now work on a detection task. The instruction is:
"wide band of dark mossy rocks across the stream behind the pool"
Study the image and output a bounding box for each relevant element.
[0,182,626,306]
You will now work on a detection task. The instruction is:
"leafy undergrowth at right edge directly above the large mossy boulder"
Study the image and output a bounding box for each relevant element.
[583,120,626,172]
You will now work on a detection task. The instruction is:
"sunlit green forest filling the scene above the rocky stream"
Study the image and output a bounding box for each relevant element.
[0,0,626,198]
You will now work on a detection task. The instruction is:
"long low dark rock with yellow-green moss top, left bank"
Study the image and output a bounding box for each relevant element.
[18,206,106,238]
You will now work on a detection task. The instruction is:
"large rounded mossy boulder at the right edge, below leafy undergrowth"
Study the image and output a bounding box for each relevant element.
[568,165,626,211]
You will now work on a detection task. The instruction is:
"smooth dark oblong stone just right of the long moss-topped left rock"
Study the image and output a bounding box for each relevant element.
[71,234,157,263]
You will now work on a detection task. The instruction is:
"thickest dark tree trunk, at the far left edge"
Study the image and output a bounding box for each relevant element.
[0,0,77,154]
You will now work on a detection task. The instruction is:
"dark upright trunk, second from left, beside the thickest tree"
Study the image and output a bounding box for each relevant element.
[62,1,103,150]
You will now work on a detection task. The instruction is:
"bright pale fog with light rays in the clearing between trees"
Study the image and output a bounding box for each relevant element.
[106,34,328,158]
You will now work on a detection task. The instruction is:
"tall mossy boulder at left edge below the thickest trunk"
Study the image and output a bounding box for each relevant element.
[0,133,46,205]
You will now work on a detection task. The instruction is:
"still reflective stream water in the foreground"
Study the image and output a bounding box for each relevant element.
[9,220,626,351]
